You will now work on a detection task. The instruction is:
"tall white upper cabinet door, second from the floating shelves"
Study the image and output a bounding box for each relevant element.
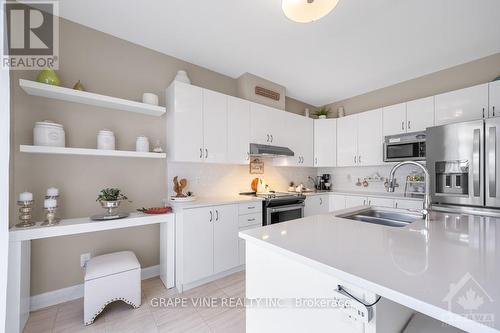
[203,89,227,163]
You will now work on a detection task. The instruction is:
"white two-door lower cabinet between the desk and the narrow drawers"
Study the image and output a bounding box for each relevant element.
[176,205,239,289]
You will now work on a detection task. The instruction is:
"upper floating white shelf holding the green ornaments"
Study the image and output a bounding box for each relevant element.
[19,79,166,117]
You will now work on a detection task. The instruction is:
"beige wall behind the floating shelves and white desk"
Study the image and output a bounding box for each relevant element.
[10,20,312,295]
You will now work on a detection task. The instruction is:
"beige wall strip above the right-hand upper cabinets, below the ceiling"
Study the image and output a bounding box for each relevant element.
[328,53,500,117]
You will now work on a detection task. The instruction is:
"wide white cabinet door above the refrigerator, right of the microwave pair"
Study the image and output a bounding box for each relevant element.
[434,83,488,126]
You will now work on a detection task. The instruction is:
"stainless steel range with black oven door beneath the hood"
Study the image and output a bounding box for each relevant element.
[240,192,306,225]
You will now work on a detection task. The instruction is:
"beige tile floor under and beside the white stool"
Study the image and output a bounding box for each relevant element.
[23,272,245,333]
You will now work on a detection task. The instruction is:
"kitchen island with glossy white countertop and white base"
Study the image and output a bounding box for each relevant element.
[240,207,500,333]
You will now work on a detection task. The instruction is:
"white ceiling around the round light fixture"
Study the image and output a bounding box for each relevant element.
[59,0,500,105]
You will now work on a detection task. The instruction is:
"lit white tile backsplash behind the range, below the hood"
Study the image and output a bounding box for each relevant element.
[167,160,316,197]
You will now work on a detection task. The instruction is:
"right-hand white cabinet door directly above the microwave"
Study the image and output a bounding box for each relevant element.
[406,96,434,133]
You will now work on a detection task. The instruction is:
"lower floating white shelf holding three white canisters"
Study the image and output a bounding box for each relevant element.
[19,145,167,158]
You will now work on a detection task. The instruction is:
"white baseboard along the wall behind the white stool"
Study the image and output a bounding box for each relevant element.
[30,265,160,311]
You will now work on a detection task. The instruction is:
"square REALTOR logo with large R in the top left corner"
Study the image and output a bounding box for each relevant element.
[2,1,59,70]
